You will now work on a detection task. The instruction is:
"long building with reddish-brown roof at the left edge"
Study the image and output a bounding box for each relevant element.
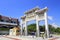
[0,15,19,34]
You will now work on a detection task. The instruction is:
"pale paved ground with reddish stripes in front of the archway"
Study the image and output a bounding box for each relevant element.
[0,36,60,40]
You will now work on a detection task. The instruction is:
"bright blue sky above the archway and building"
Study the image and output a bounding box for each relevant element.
[0,0,60,26]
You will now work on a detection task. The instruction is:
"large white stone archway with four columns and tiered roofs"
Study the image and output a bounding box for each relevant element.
[21,7,49,37]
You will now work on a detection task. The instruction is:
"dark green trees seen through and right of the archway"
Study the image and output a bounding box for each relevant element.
[28,24,60,33]
